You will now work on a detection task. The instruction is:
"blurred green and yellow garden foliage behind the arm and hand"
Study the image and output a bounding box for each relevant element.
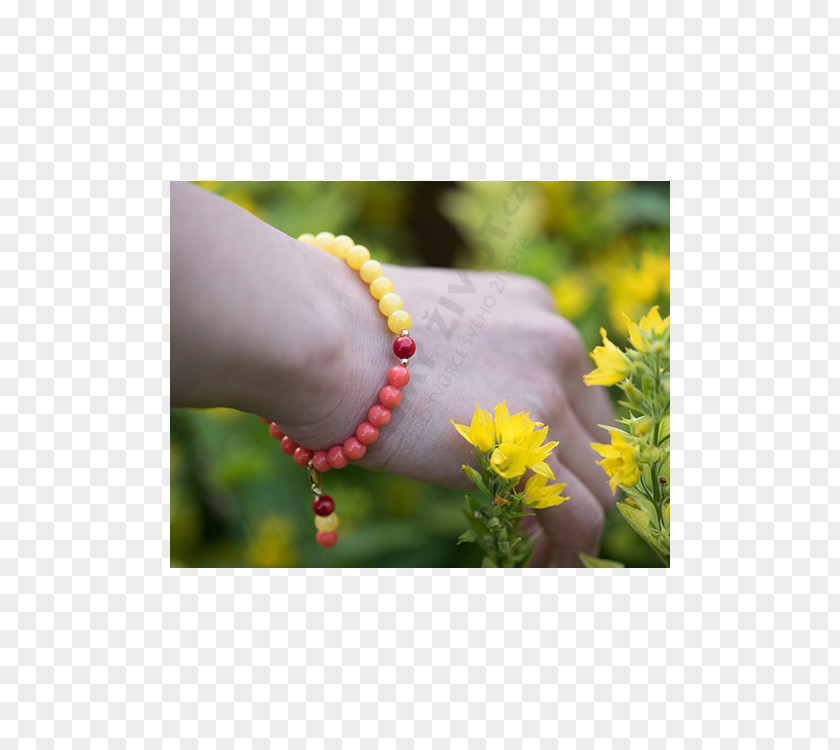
[170,182,670,567]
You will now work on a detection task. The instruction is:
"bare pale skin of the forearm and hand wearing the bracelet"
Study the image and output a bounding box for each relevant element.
[170,183,614,566]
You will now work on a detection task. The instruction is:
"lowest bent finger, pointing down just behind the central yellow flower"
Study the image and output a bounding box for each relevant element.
[536,456,604,568]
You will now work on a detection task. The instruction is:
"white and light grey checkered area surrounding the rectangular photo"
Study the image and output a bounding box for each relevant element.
[0,0,840,750]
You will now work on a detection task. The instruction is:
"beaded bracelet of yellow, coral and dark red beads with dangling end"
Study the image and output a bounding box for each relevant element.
[262,232,416,547]
